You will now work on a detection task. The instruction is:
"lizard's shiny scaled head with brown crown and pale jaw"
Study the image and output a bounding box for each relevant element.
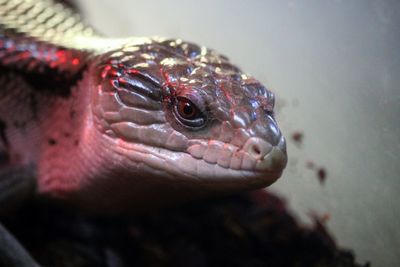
[68,39,287,214]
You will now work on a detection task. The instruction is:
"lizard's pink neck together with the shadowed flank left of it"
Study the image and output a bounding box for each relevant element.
[0,71,97,194]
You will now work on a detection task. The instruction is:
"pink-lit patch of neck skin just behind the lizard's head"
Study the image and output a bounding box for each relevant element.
[37,72,96,198]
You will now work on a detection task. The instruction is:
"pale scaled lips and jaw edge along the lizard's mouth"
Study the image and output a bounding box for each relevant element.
[117,137,287,187]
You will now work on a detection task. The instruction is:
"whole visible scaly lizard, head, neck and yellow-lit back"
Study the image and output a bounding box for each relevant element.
[0,1,287,213]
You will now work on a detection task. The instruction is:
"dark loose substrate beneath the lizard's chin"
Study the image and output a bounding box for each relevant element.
[5,191,369,267]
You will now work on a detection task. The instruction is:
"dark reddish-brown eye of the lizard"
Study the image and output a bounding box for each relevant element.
[174,96,206,129]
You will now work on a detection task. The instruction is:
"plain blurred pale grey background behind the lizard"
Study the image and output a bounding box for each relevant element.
[81,0,400,266]
